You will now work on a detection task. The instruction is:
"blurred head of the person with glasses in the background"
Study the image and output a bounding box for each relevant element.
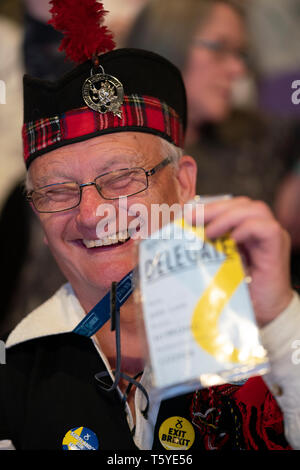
[127,0,247,144]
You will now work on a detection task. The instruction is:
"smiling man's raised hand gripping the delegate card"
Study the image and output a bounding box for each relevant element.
[186,197,293,326]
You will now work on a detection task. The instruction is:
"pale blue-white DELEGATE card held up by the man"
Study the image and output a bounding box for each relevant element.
[139,224,266,388]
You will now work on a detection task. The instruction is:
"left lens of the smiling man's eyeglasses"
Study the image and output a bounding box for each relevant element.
[32,183,80,212]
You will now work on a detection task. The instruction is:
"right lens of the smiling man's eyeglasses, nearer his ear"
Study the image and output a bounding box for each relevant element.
[95,168,147,199]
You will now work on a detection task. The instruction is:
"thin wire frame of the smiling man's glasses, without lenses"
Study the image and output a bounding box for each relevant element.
[26,157,172,213]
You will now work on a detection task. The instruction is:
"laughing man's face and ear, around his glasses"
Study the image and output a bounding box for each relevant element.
[30,132,196,310]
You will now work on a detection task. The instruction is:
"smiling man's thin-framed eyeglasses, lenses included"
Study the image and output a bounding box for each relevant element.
[26,157,171,213]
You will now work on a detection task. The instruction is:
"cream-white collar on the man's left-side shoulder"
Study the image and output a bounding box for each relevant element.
[6,283,85,348]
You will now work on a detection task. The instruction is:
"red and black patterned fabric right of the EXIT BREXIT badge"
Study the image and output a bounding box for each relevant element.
[190,377,292,450]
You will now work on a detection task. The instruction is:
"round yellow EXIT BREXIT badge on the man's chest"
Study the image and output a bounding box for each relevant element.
[158,416,195,450]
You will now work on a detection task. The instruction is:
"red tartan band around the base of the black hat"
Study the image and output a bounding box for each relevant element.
[22,95,184,168]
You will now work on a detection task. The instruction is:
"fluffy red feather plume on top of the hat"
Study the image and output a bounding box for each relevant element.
[49,0,115,64]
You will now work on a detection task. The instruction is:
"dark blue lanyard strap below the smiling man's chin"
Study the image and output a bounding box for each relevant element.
[73,271,133,337]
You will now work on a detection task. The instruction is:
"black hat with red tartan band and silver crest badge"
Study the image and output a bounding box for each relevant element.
[22,49,187,169]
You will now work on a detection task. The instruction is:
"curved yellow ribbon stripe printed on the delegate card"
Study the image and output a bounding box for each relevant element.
[191,254,244,363]
